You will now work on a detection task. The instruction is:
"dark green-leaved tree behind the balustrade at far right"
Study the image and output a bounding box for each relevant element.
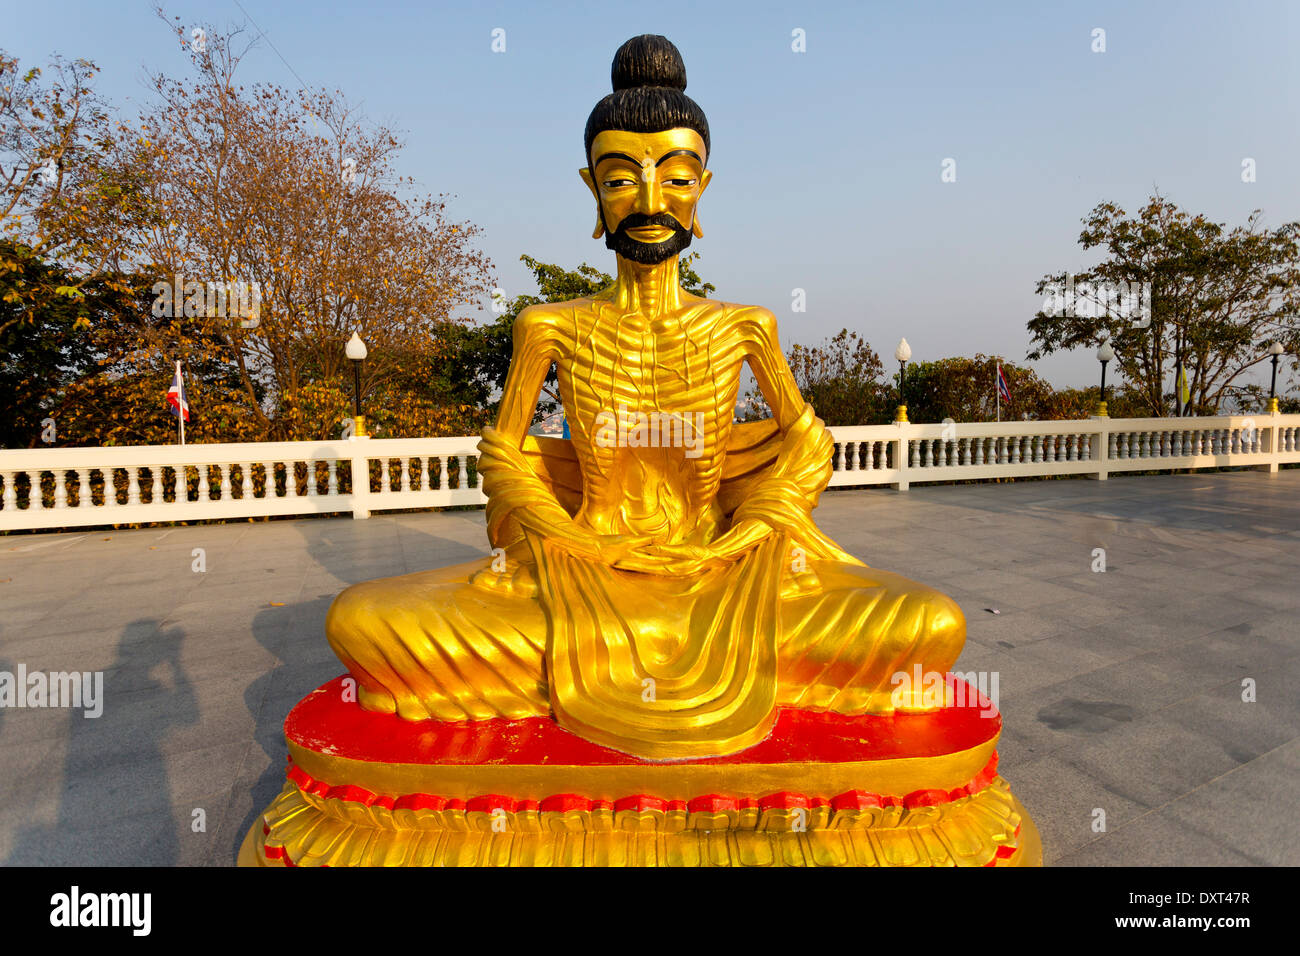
[1028,194,1300,416]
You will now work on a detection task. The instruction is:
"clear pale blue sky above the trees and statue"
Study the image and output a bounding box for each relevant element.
[0,0,1300,385]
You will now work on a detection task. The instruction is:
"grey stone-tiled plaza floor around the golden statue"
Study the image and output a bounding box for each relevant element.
[0,471,1300,866]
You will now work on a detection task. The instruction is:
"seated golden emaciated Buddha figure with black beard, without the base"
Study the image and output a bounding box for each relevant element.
[326,36,965,760]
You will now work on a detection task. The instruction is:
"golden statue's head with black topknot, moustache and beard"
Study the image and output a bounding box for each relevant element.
[579,34,712,264]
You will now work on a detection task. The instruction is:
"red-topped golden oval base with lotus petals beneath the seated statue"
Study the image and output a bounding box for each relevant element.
[239,678,1043,866]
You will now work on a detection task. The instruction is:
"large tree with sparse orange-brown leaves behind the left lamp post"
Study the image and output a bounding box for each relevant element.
[104,18,493,440]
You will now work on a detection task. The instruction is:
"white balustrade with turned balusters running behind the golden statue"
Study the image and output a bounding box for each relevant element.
[0,414,1300,531]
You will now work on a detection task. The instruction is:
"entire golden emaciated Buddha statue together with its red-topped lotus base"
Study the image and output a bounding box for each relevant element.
[239,36,1041,866]
